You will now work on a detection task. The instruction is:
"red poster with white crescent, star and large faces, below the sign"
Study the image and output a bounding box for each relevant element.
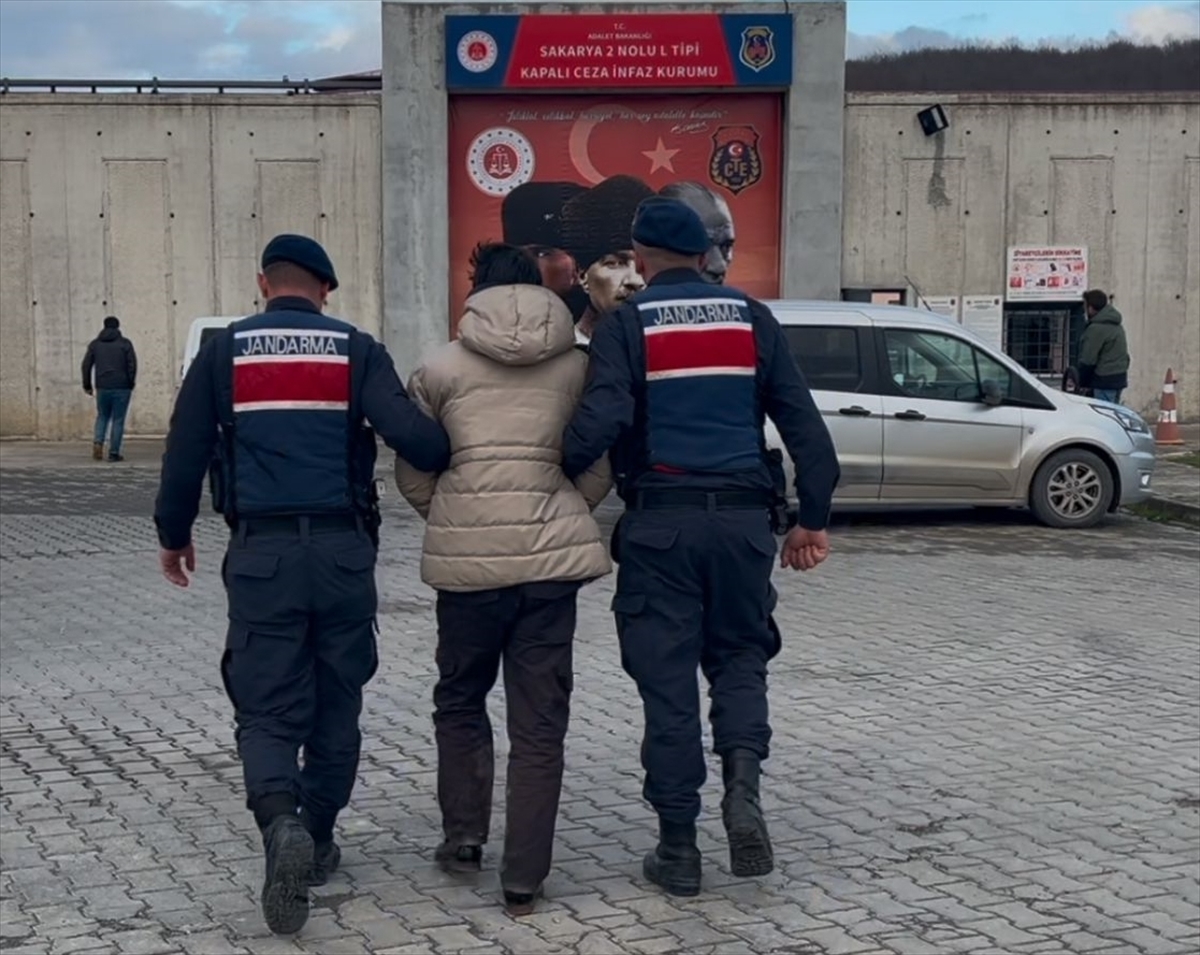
[449,94,782,322]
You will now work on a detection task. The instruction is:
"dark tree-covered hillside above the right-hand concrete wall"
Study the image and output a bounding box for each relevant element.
[846,40,1200,92]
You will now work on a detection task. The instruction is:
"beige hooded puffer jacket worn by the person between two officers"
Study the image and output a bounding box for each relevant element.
[396,286,612,591]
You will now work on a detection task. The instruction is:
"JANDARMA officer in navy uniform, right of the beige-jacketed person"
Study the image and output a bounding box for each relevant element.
[563,197,839,895]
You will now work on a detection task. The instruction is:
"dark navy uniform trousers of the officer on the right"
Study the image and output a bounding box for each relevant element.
[612,509,780,823]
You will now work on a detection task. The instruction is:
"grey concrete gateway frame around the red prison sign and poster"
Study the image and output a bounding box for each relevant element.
[383,0,846,373]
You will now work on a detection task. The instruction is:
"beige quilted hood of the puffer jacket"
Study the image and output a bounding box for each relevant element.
[458,286,575,365]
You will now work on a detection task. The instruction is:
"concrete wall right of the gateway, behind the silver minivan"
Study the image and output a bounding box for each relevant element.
[842,94,1200,420]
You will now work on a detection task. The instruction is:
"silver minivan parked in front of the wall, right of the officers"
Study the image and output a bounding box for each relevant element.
[767,301,1154,528]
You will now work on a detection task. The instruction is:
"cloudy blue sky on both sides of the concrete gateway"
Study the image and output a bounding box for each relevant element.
[0,0,1200,79]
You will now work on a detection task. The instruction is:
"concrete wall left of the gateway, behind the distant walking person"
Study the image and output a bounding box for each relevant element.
[0,94,380,438]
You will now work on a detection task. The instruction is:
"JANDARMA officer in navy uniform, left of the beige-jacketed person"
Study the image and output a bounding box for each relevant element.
[155,235,450,933]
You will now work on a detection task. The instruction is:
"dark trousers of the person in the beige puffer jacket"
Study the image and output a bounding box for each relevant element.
[433,582,580,893]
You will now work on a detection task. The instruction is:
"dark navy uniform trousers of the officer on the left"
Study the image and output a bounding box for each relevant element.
[221,517,378,839]
